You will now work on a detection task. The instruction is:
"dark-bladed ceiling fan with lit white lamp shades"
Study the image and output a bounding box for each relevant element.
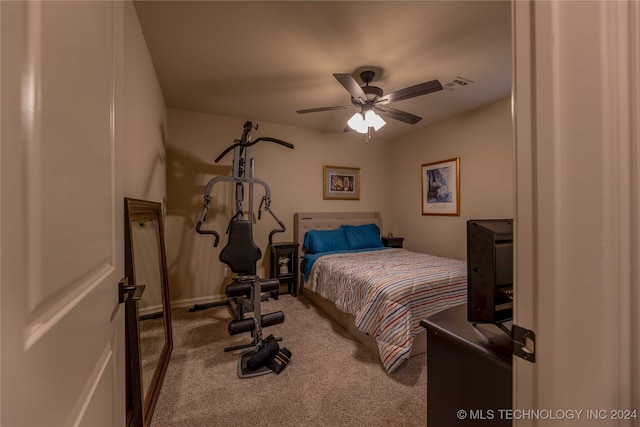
[297,70,442,133]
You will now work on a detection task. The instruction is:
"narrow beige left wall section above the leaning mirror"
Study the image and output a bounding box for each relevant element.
[124,1,167,203]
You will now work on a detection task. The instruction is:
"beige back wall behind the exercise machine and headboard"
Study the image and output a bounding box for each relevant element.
[167,109,391,304]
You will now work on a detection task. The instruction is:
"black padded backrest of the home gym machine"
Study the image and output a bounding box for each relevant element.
[220,219,262,274]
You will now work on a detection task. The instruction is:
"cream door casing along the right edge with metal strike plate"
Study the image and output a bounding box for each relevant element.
[513,1,640,426]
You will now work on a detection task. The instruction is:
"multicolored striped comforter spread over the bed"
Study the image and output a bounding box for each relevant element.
[305,249,467,373]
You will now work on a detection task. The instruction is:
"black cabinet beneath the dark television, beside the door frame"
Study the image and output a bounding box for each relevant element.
[420,304,512,427]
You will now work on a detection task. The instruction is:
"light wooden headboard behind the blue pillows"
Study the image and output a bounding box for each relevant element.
[293,212,382,255]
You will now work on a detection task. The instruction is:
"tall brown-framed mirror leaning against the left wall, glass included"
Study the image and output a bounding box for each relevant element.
[124,198,173,427]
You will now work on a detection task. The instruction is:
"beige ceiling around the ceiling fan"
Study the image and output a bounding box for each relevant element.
[134,0,512,139]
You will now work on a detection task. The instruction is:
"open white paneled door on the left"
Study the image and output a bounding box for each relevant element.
[0,1,125,427]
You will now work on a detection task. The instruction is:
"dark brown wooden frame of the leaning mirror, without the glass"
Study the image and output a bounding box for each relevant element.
[124,198,173,427]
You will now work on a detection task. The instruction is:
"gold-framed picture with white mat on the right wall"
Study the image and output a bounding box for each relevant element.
[422,157,460,216]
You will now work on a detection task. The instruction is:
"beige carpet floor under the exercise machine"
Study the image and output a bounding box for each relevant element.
[151,294,427,427]
